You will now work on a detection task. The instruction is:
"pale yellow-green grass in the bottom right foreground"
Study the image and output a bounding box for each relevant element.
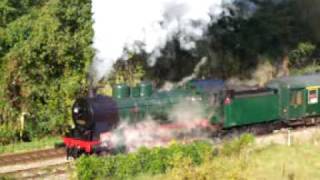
[135,132,320,180]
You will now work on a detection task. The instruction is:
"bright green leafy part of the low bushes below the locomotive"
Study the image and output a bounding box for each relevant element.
[76,142,213,179]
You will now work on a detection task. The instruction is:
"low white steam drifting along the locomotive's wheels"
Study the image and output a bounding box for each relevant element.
[100,100,212,152]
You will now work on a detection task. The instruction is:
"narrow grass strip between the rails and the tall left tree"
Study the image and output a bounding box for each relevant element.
[0,137,62,154]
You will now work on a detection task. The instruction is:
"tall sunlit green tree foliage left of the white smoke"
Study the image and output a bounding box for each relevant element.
[0,0,93,143]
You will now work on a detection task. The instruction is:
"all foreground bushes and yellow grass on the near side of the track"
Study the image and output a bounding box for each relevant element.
[76,132,320,180]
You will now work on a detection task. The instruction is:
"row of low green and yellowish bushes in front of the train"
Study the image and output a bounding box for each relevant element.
[76,135,254,179]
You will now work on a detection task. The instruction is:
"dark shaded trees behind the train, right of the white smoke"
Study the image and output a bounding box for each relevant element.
[146,0,320,81]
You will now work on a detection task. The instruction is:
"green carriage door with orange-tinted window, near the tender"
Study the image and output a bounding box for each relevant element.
[289,89,305,119]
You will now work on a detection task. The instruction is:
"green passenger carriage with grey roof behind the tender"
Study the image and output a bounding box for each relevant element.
[267,74,320,121]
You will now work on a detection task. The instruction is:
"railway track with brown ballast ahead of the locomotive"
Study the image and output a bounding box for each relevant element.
[0,148,70,179]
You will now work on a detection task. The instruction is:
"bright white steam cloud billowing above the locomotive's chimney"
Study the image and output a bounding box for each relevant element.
[90,0,223,83]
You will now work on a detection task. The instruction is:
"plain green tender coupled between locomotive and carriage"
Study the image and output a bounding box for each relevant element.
[216,89,279,128]
